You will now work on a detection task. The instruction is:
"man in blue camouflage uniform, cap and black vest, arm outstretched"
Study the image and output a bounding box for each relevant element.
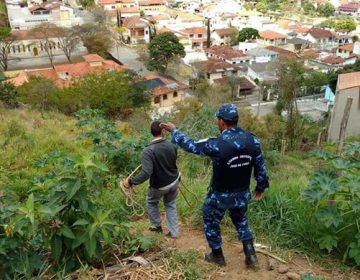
[161,104,269,266]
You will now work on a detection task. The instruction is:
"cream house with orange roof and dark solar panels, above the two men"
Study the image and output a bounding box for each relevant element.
[142,74,189,108]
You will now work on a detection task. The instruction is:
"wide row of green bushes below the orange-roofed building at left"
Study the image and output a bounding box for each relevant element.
[14,70,149,118]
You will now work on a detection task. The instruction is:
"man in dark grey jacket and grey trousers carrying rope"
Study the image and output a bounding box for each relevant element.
[122,121,180,238]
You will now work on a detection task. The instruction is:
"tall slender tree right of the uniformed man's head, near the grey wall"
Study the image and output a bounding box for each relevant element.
[278,57,304,148]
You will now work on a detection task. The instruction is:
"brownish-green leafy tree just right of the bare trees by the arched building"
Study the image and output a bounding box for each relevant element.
[75,23,114,56]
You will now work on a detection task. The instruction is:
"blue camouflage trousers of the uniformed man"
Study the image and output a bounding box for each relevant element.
[203,191,253,249]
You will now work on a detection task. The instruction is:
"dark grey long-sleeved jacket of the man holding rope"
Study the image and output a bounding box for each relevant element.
[129,138,179,189]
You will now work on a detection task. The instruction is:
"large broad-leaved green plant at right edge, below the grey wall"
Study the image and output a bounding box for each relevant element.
[303,142,360,265]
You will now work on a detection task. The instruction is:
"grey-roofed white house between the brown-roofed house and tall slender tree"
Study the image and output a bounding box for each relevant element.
[247,61,278,82]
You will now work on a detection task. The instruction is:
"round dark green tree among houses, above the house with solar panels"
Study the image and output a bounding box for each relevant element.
[147,32,185,73]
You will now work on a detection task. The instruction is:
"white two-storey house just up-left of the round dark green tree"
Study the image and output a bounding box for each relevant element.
[122,16,151,45]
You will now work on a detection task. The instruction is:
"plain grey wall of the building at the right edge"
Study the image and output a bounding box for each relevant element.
[328,87,360,141]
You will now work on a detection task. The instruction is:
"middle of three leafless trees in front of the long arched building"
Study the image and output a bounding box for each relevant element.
[31,23,58,68]
